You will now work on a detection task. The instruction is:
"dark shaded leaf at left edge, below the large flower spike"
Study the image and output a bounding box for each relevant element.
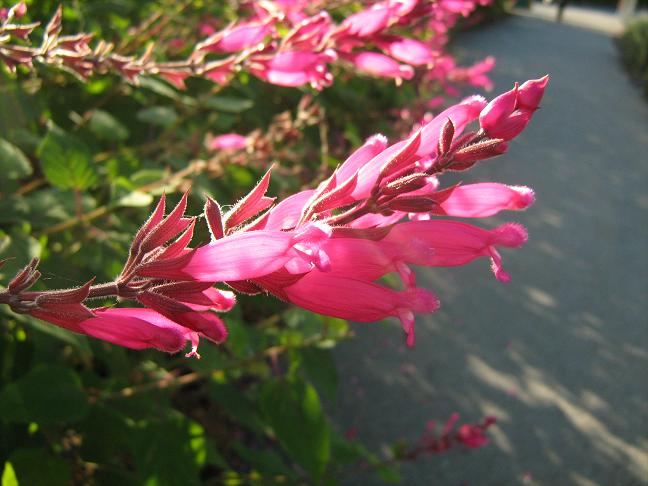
[0,364,88,424]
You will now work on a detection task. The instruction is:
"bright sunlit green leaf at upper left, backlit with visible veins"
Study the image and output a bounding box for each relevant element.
[38,125,97,189]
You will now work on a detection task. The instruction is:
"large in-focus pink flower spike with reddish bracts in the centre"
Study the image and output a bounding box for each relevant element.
[0,77,548,356]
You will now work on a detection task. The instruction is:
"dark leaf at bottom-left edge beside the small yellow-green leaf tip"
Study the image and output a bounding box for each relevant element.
[8,449,72,486]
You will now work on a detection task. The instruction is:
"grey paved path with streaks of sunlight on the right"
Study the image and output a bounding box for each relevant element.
[335,13,648,486]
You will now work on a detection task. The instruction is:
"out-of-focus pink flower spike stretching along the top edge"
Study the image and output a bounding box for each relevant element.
[0,0,493,91]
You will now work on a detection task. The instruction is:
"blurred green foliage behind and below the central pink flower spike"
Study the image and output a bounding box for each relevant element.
[0,0,498,486]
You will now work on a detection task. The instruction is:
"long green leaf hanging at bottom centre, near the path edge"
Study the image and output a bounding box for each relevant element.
[261,380,330,476]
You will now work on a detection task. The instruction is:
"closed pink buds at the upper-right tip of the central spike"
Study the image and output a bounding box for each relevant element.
[479,76,549,140]
